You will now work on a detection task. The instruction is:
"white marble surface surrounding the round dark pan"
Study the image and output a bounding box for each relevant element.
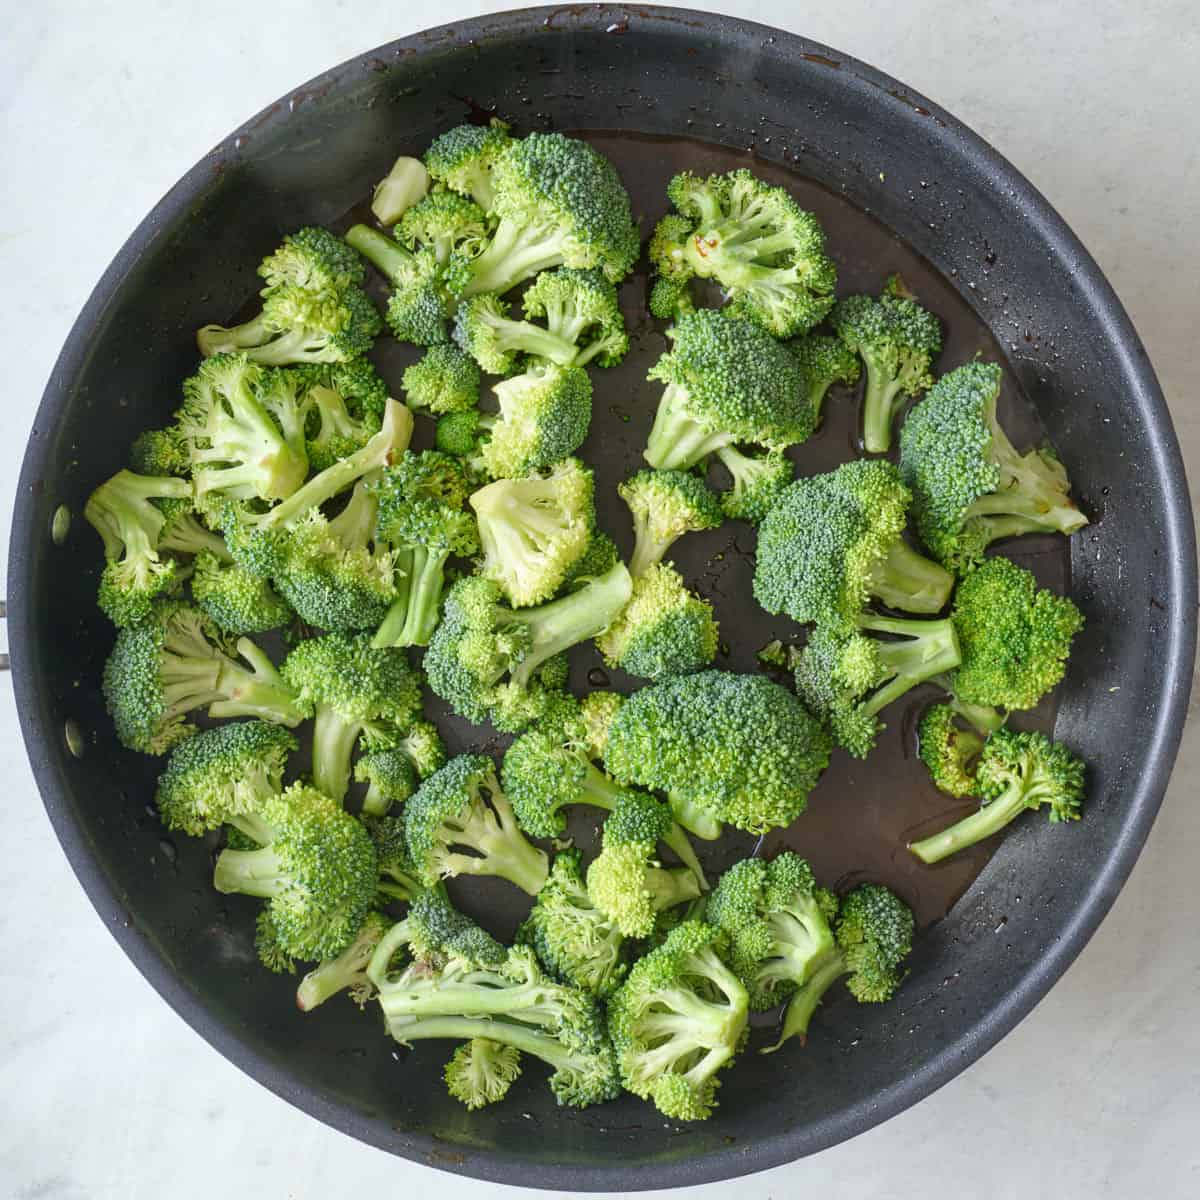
[0,0,1200,1200]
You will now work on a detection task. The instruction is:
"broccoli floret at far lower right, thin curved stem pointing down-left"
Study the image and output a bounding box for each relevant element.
[763,883,913,1054]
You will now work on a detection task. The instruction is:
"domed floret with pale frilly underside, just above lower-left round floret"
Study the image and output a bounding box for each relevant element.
[155,721,298,845]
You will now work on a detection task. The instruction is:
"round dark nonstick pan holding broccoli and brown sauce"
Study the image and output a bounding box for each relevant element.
[8,6,1196,1190]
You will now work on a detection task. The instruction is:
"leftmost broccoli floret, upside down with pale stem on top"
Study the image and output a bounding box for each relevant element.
[83,470,192,625]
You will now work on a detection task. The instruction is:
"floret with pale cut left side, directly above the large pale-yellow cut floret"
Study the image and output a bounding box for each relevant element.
[479,361,592,479]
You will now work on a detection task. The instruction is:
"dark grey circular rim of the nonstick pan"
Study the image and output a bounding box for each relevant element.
[7,6,1196,1190]
